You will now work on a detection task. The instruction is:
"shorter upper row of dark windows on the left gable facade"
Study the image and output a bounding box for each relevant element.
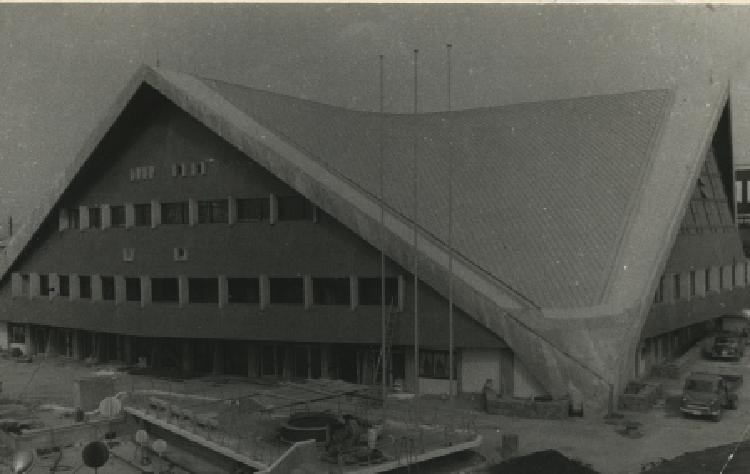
[66,196,314,229]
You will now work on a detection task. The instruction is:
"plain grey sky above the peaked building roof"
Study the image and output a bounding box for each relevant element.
[0,3,750,233]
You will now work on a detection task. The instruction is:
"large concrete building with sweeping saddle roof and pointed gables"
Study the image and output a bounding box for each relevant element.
[0,67,750,409]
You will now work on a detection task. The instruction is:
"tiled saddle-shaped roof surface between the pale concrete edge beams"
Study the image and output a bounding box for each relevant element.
[202,79,671,307]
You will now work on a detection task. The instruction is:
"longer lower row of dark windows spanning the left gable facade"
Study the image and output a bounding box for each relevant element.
[17,274,399,306]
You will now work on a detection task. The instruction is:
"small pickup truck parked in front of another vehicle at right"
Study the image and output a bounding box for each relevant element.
[680,372,742,421]
